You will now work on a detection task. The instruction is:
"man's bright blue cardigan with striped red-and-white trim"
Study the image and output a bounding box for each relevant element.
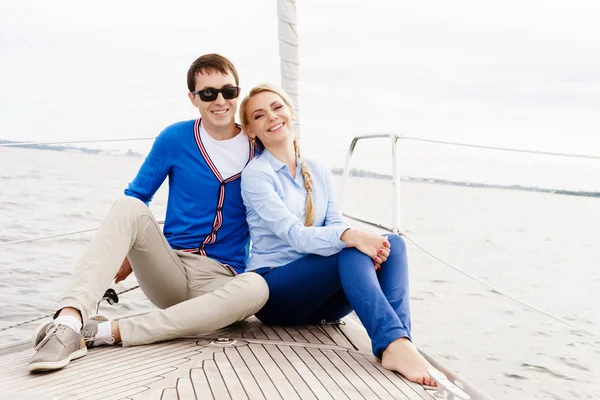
[125,119,254,273]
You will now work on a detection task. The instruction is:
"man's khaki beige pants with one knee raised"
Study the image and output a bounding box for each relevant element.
[60,197,269,346]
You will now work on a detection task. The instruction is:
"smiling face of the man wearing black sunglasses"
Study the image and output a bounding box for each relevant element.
[189,71,239,130]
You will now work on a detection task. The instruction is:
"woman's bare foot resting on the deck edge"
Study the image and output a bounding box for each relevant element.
[381,338,437,386]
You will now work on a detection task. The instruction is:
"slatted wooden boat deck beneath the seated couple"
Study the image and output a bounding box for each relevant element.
[0,318,436,400]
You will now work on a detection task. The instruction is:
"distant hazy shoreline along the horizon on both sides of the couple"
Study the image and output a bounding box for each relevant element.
[0,139,600,198]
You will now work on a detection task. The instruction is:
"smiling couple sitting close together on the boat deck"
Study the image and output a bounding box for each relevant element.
[29,54,435,384]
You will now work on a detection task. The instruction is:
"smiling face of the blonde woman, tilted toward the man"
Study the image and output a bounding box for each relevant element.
[246,92,293,149]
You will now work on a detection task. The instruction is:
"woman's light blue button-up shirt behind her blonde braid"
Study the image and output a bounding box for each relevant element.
[242,150,348,271]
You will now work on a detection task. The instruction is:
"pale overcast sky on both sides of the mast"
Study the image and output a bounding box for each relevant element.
[0,0,600,177]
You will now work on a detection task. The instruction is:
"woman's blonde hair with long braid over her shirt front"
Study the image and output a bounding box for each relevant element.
[240,83,315,226]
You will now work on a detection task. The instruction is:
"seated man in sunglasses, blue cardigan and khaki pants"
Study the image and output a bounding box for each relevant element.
[29,54,268,371]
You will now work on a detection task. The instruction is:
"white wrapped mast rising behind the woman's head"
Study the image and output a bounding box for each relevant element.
[277,0,300,140]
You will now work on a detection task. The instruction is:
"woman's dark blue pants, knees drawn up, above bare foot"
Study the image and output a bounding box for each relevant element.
[256,235,410,358]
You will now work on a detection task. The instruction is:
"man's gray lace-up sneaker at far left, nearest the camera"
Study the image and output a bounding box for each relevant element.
[29,322,87,372]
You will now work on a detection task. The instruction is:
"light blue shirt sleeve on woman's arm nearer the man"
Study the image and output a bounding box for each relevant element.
[242,168,347,256]
